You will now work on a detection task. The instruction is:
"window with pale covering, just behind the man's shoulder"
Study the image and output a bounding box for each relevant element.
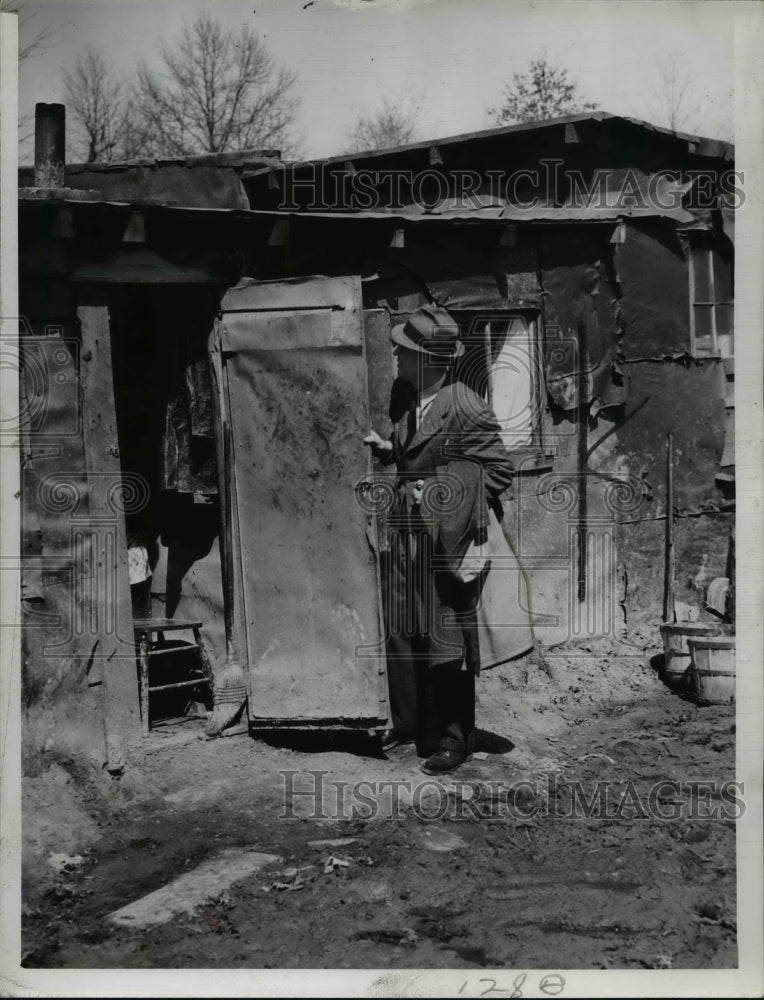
[454,311,544,451]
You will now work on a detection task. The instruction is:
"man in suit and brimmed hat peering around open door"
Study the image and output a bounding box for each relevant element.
[364,306,532,774]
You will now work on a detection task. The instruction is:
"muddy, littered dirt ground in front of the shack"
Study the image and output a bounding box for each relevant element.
[22,642,737,969]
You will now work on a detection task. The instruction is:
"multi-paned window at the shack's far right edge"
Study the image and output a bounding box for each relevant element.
[690,236,733,357]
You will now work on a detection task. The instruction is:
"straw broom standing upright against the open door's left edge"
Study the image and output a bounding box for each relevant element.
[205,404,247,736]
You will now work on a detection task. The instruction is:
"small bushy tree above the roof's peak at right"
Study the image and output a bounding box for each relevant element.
[487,56,597,125]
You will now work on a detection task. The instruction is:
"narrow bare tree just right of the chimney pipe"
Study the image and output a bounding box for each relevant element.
[64,45,125,163]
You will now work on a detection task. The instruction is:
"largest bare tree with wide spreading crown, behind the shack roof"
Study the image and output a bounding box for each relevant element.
[135,13,299,156]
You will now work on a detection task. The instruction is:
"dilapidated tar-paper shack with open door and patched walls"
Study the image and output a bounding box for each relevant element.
[19,112,740,766]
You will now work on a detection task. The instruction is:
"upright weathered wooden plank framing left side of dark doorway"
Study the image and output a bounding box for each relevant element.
[77,291,140,771]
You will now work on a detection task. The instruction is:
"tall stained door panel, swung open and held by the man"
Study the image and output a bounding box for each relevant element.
[219,277,387,727]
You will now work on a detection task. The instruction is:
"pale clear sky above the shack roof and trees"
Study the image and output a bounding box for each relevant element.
[14,0,735,163]
